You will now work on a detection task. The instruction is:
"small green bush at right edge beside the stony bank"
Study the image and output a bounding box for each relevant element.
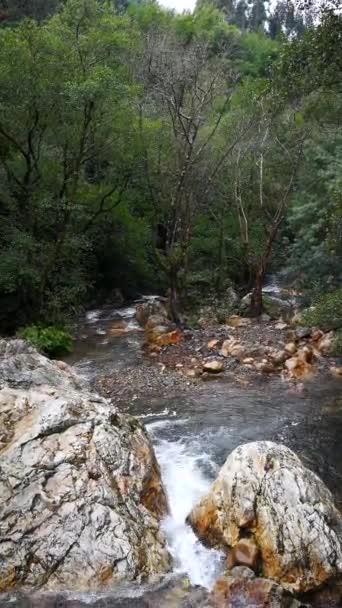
[303,287,342,330]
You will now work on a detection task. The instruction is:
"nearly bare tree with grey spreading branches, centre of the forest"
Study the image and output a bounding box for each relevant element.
[134,4,243,322]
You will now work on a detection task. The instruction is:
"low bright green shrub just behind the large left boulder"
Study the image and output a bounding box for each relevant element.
[18,325,73,357]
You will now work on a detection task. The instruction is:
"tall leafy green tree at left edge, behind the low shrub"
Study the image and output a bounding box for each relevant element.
[0,0,138,328]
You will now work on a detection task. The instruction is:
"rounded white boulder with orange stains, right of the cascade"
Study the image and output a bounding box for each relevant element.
[187,441,342,592]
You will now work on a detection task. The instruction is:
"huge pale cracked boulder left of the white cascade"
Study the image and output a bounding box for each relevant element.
[0,341,170,591]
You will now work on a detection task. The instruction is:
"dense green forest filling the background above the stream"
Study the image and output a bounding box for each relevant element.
[0,0,342,342]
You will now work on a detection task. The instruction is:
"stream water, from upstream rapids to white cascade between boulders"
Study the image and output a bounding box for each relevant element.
[62,300,342,588]
